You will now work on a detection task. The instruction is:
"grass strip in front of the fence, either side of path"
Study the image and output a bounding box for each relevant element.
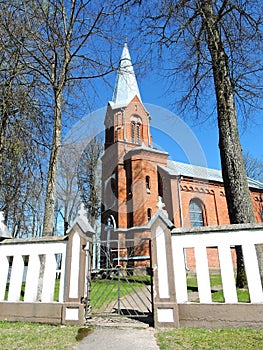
[0,322,263,350]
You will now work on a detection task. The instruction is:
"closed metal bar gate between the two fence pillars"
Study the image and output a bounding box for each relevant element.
[88,238,153,322]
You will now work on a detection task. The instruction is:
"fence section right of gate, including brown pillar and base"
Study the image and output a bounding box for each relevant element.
[151,216,263,329]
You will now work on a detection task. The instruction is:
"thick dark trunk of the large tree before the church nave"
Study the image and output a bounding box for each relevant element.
[201,0,262,288]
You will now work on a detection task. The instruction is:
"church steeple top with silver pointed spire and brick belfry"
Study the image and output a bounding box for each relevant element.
[104,43,152,150]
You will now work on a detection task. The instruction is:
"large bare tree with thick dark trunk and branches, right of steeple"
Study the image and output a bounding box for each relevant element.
[132,0,263,287]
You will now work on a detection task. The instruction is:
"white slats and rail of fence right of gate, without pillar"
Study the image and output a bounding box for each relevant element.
[172,230,263,304]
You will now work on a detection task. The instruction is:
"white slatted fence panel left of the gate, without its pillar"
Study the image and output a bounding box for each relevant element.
[0,239,67,303]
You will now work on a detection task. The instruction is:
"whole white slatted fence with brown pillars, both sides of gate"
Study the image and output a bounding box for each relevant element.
[0,212,263,328]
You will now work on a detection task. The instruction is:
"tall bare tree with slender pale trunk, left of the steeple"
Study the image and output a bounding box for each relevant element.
[2,0,121,236]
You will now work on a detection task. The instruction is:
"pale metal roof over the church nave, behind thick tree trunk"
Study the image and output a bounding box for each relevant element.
[165,160,263,189]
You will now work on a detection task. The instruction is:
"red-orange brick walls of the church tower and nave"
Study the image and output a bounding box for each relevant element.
[102,92,263,268]
